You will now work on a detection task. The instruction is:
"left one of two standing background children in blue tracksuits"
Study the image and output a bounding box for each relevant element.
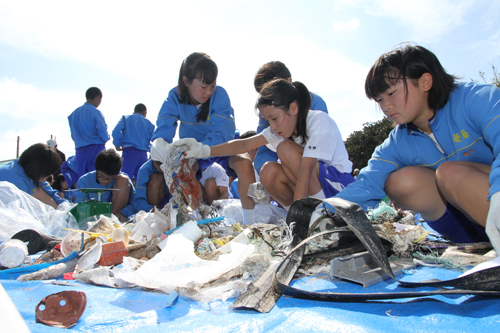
[68,87,110,177]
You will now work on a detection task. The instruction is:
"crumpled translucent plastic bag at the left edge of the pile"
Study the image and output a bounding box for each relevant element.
[0,181,79,242]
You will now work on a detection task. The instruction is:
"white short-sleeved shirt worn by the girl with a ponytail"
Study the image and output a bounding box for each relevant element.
[261,110,352,173]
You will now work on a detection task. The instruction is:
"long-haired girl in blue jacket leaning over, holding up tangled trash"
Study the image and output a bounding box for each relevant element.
[153,52,255,224]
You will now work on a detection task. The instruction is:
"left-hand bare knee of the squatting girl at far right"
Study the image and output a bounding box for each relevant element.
[385,166,446,221]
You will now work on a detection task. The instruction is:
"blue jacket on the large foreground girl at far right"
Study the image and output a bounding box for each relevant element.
[337,82,500,209]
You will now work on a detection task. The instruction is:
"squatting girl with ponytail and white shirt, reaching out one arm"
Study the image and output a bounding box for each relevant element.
[174,79,354,209]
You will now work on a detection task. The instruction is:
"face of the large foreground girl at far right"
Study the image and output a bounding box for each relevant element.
[375,74,434,126]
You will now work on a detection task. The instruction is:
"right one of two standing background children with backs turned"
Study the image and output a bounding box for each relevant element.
[112,103,155,182]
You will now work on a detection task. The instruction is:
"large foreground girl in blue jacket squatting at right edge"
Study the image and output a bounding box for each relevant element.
[337,45,500,246]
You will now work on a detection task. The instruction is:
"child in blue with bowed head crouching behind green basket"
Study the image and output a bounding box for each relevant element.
[76,149,137,222]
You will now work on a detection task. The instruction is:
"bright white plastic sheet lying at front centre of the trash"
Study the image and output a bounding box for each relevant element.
[112,229,264,302]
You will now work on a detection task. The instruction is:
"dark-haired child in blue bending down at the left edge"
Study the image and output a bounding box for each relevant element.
[0,143,68,208]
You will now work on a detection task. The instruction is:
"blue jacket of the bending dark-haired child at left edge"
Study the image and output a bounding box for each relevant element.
[0,160,68,205]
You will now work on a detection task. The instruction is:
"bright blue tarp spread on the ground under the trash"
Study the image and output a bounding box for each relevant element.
[0,267,500,333]
